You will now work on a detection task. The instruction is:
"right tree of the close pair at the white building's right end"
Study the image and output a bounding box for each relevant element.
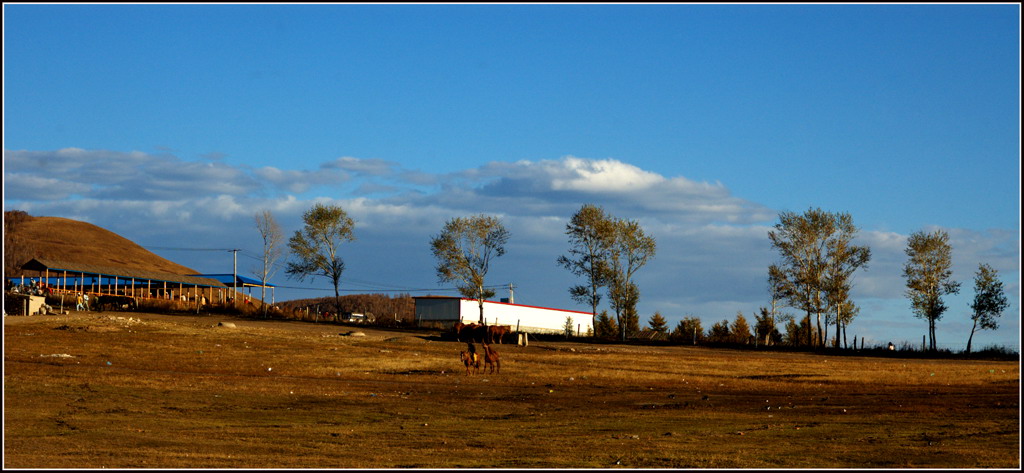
[608,219,657,341]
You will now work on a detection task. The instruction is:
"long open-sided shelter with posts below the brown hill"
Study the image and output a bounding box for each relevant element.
[7,258,227,307]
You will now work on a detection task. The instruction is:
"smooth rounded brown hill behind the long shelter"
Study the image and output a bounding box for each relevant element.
[3,210,199,277]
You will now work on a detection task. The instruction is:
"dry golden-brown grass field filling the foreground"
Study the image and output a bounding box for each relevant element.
[3,312,1020,469]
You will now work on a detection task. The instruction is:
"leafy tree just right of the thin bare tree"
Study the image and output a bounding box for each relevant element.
[285,203,355,321]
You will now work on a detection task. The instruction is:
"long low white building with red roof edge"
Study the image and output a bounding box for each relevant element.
[413,296,593,335]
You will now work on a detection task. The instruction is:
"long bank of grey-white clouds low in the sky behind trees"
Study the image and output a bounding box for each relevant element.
[4,148,1020,346]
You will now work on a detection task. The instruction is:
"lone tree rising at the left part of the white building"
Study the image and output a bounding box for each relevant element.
[430,214,509,324]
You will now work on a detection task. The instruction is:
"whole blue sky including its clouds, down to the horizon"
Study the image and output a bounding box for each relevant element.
[3,4,1020,348]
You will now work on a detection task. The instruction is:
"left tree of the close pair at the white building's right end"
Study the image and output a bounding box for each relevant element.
[558,204,614,326]
